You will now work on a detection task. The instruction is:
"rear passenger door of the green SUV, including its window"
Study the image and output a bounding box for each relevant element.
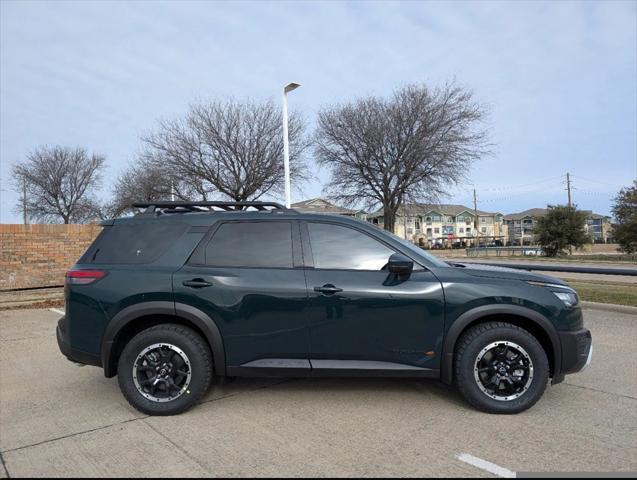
[173,220,309,374]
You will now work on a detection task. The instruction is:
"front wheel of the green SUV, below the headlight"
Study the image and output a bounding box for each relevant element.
[454,322,550,414]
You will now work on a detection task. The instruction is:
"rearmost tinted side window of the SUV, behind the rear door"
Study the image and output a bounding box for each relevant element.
[81,223,188,264]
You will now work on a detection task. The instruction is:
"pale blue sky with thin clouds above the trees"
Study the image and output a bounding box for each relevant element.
[0,0,637,223]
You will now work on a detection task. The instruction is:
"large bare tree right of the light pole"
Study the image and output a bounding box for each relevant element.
[316,82,488,231]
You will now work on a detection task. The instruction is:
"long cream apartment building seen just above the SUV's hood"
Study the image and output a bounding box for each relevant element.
[367,204,506,248]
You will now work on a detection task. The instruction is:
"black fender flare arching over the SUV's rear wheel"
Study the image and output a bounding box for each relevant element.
[101,301,226,378]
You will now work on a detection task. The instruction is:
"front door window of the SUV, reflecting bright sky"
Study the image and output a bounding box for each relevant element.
[308,223,394,270]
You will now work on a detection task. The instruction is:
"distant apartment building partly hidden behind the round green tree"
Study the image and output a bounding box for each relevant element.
[504,208,612,245]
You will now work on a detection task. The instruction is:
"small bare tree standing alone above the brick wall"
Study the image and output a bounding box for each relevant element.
[13,146,105,223]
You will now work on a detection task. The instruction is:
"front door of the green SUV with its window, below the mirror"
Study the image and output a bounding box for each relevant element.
[302,221,444,374]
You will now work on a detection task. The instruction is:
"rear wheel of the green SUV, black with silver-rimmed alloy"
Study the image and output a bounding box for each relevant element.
[118,324,212,415]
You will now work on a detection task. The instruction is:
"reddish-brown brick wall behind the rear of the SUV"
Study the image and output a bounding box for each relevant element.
[0,224,102,290]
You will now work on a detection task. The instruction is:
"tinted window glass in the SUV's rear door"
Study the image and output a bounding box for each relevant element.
[206,222,293,268]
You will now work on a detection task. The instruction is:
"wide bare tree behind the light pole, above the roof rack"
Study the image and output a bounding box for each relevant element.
[143,100,309,201]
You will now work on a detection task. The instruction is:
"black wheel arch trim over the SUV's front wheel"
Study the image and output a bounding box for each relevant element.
[440,305,562,384]
